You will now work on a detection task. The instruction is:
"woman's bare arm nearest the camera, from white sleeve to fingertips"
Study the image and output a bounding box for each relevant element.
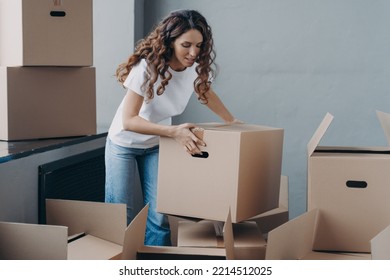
[122,90,205,154]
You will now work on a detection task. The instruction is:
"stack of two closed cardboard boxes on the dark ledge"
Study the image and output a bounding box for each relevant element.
[0,0,96,141]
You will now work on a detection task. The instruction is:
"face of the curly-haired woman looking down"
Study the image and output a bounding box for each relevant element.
[169,29,203,71]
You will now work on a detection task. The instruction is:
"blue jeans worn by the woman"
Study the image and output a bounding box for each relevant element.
[105,137,171,246]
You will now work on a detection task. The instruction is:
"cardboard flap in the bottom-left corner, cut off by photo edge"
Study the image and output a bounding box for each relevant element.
[0,222,68,260]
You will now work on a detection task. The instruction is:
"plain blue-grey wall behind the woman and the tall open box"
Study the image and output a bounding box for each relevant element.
[143,0,390,218]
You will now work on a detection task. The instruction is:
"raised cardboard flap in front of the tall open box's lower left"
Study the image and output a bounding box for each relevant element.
[266,209,319,260]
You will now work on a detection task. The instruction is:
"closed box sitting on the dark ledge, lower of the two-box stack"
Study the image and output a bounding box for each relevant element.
[0,66,96,140]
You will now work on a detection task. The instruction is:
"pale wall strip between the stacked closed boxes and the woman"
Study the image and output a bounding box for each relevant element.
[93,0,135,132]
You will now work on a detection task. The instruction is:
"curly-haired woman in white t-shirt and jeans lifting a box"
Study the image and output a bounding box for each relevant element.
[106,10,235,246]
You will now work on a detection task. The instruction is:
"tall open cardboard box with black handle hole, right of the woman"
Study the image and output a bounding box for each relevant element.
[308,112,390,253]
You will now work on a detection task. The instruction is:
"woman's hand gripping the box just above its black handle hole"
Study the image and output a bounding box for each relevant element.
[172,123,206,155]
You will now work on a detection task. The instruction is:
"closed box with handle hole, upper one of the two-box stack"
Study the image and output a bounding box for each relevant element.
[0,0,93,66]
